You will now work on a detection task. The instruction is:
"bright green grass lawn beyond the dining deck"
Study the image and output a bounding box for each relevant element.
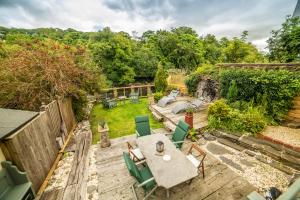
[90,98,163,144]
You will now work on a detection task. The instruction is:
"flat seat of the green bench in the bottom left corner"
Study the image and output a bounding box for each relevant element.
[1,182,31,200]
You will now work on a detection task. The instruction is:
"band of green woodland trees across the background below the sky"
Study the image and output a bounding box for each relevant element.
[0,27,264,86]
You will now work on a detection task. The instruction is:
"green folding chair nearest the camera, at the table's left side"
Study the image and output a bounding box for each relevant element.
[123,152,157,200]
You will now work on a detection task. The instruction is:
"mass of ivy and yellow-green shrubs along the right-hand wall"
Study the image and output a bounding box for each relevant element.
[186,65,300,134]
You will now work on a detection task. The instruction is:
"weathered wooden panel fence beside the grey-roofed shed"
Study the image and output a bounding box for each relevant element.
[0,99,75,191]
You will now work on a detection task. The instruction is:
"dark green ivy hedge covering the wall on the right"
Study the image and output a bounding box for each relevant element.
[220,69,300,122]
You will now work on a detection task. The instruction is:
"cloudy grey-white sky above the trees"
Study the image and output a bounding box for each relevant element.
[0,0,297,50]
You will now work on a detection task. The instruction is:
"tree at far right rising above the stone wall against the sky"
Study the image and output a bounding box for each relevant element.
[267,16,300,62]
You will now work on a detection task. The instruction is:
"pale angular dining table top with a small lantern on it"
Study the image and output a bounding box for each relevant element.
[136,133,198,189]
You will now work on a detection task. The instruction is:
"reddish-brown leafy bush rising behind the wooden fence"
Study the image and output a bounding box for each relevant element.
[0,34,102,120]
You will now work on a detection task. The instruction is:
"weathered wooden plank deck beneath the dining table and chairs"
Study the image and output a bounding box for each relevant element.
[95,129,256,200]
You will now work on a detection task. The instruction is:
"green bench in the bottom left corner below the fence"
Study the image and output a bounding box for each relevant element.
[0,161,35,200]
